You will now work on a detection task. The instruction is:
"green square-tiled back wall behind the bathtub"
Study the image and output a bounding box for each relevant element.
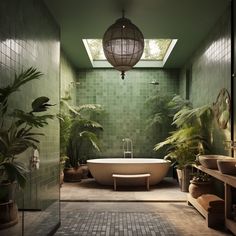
[76,69,179,157]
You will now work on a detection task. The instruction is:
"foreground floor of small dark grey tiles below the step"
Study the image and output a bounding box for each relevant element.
[55,202,232,236]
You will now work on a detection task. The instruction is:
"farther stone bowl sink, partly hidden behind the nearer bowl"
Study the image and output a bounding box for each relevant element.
[198,155,232,170]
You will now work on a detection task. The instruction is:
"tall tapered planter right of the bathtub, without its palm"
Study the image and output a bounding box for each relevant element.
[176,167,192,192]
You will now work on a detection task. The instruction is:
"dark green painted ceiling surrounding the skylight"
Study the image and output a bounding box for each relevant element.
[45,0,230,69]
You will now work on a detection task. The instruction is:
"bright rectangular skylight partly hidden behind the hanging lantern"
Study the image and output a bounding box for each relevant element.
[83,39,177,67]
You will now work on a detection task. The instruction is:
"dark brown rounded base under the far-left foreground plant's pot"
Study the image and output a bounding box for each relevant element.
[0,200,18,229]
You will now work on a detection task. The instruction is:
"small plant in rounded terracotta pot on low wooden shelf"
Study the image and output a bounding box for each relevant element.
[189,170,213,198]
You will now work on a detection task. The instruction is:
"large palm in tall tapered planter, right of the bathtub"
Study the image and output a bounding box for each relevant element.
[154,98,213,192]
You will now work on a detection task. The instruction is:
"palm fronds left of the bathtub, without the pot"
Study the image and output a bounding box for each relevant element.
[59,99,103,168]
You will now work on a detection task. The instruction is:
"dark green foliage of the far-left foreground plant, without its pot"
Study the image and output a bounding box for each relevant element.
[0,68,53,187]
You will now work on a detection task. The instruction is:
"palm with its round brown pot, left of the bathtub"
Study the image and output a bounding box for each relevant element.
[61,99,103,182]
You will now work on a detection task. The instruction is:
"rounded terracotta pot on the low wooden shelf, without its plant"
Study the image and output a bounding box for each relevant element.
[189,180,213,198]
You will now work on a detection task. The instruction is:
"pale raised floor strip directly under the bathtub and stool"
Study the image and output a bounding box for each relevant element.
[61,178,186,202]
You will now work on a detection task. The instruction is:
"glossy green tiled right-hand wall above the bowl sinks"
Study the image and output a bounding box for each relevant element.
[180,6,231,154]
